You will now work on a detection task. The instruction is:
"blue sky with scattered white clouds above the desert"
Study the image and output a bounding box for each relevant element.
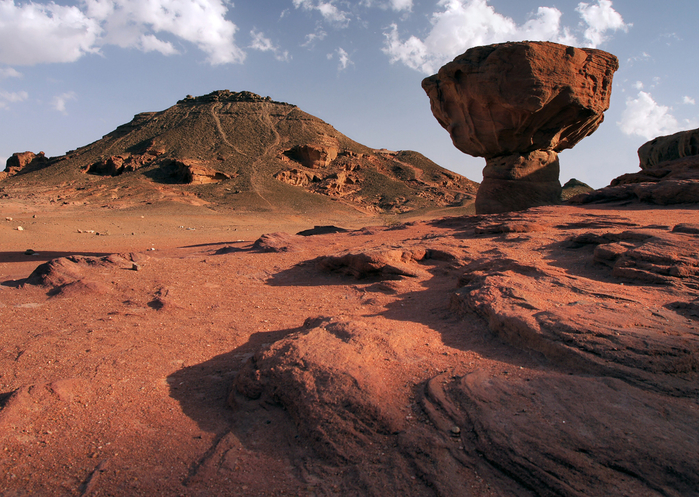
[0,0,699,187]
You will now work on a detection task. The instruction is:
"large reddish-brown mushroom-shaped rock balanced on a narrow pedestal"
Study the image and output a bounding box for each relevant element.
[422,42,619,214]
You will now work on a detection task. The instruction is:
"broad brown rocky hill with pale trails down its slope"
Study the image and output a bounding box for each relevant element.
[0,90,478,214]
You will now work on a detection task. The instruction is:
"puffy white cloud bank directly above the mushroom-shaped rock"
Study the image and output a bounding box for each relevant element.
[383,0,628,74]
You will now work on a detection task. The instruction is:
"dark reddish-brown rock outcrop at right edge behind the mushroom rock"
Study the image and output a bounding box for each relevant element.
[571,129,699,205]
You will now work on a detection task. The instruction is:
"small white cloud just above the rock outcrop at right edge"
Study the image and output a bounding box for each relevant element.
[617,91,697,140]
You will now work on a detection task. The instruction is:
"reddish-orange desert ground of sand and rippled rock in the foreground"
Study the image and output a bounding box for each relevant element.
[0,184,699,496]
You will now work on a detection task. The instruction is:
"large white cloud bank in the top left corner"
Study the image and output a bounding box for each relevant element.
[0,0,245,65]
